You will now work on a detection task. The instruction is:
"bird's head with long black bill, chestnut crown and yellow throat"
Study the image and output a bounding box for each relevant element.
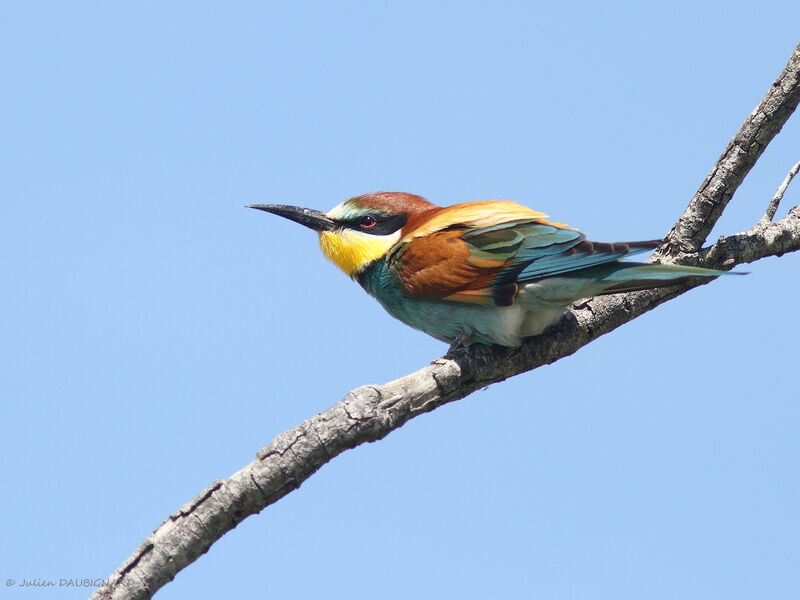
[250,192,440,278]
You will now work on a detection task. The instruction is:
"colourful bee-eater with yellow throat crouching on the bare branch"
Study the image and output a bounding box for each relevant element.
[248,192,725,350]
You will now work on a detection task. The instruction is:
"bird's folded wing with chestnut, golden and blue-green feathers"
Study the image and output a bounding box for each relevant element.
[387,202,658,306]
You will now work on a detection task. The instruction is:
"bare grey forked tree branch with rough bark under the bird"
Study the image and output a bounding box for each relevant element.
[92,45,800,600]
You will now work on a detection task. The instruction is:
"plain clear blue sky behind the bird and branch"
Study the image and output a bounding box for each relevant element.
[0,1,800,600]
